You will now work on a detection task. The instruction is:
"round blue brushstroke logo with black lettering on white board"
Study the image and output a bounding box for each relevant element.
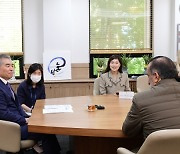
[48,57,66,76]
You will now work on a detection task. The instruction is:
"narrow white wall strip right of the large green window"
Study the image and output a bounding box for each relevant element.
[153,0,172,56]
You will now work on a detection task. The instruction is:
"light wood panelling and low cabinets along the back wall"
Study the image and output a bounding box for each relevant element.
[11,63,136,98]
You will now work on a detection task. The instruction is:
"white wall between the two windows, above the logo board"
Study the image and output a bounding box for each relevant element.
[24,0,89,64]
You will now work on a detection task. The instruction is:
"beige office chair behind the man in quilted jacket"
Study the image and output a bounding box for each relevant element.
[117,129,180,154]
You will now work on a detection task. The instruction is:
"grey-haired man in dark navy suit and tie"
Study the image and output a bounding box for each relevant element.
[0,54,60,154]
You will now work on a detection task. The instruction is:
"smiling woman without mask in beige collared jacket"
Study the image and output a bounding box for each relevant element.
[99,55,131,95]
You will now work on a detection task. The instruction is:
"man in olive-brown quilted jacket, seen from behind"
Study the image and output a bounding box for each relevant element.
[122,56,180,139]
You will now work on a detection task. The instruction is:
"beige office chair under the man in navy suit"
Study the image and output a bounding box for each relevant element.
[0,120,35,153]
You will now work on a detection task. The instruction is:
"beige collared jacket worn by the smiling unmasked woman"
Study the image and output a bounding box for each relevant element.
[99,72,131,95]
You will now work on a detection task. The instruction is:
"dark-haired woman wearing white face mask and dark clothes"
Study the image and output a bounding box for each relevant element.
[17,63,46,112]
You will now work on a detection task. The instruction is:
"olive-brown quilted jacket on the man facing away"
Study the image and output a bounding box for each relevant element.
[122,79,180,138]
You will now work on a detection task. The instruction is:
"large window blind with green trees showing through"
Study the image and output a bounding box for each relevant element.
[90,0,152,52]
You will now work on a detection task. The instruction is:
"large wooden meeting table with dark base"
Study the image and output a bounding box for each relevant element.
[28,95,141,154]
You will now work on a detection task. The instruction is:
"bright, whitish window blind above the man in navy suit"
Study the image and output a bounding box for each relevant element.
[0,0,22,54]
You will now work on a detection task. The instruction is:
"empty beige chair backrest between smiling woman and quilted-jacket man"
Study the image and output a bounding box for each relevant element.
[136,75,150,92]
